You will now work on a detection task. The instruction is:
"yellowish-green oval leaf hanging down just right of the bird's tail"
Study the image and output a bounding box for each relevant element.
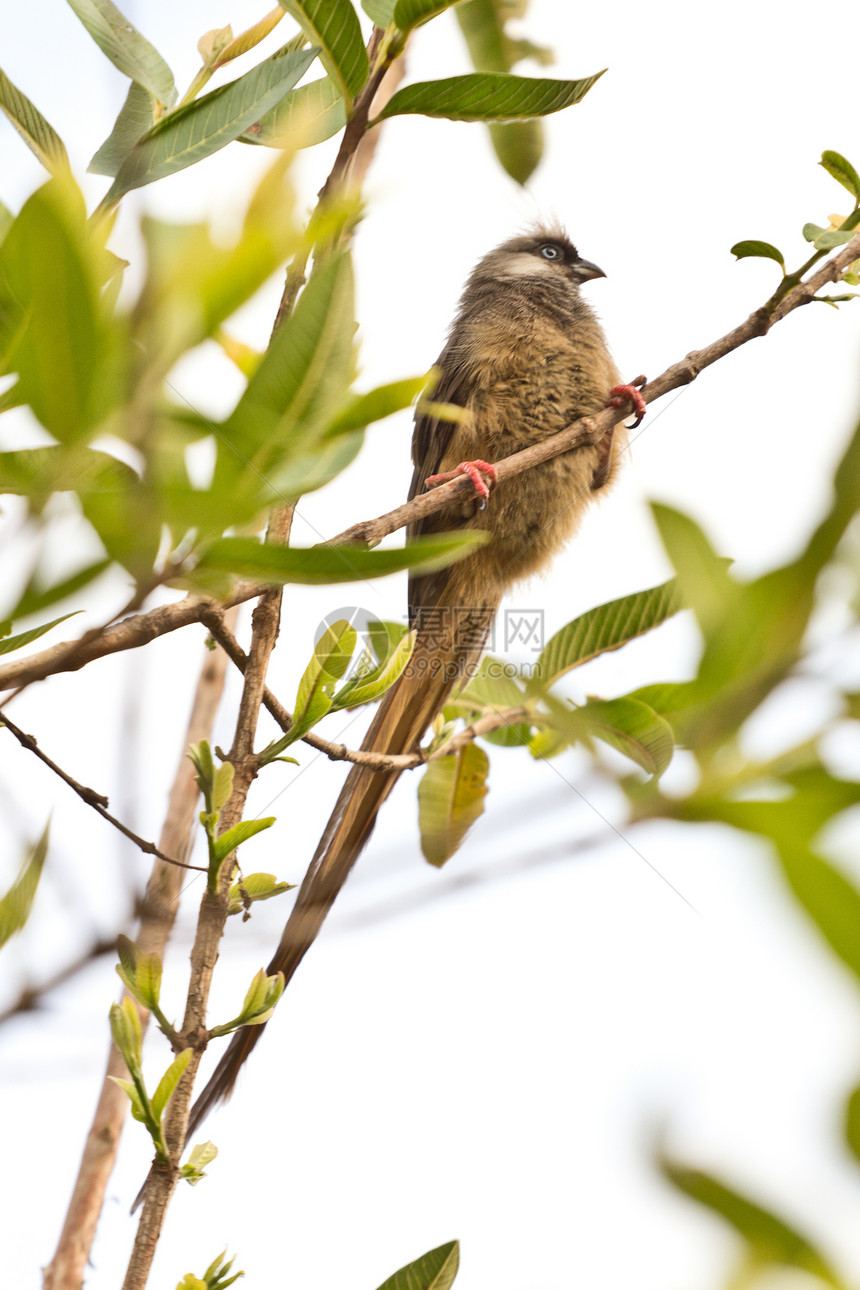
[418,743,490,867]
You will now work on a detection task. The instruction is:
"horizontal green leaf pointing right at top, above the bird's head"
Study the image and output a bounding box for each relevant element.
[376,68,605,121]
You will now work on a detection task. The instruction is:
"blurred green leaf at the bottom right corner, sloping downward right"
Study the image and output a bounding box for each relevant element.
[660,1158,843,1287]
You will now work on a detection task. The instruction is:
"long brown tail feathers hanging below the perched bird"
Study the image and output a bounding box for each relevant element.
[188,606,495,1134]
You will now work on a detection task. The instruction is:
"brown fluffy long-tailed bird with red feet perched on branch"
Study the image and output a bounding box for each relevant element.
[188,224,645,1134]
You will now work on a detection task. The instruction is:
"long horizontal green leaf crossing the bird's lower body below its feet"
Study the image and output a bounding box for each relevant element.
[197,531,487,586]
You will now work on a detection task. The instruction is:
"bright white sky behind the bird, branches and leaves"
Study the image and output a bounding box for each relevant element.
[0,0,860,1290]
